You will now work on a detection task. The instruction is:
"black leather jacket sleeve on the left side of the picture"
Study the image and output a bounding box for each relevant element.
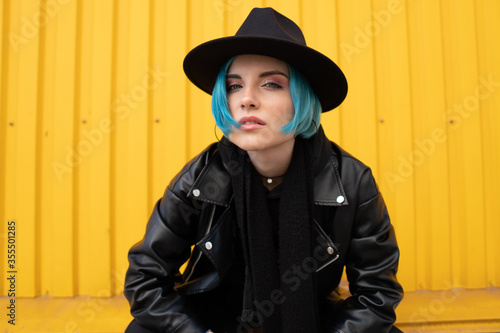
[124,155,209,333]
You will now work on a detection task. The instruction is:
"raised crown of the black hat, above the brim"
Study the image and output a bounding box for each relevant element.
[235,8,306,46]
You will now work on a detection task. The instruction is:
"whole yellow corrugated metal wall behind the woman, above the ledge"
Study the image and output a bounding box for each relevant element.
[0,0,500,297]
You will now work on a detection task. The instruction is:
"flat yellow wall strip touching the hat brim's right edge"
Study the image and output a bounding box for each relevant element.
[334,0,377,175]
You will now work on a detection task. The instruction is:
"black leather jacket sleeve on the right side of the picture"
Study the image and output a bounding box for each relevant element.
[329,170,403,333]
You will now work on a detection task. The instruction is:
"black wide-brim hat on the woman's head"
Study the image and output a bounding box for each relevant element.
[184,8,347,112]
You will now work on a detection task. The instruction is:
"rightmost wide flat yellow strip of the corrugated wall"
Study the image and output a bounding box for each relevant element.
[442,0,486,288]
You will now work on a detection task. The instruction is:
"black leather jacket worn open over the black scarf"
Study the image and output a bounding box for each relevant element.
[125,143,403,333]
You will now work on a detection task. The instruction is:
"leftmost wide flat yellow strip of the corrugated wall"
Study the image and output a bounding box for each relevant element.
[6,1,40,296]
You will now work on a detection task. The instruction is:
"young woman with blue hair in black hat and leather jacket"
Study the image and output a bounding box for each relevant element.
[125,8,403,333]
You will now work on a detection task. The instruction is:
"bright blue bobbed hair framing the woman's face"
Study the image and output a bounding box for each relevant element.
[212,57,321,139]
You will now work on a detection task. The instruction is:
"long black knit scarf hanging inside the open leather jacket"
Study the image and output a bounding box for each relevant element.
[218,127,331,333]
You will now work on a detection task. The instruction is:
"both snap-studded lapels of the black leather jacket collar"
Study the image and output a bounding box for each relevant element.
[188,147,348,207]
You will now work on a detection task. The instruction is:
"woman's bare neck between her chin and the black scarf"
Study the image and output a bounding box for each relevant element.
[248,136,295,188]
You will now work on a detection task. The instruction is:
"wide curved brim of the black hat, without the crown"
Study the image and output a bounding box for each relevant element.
[183,36,347,112]
